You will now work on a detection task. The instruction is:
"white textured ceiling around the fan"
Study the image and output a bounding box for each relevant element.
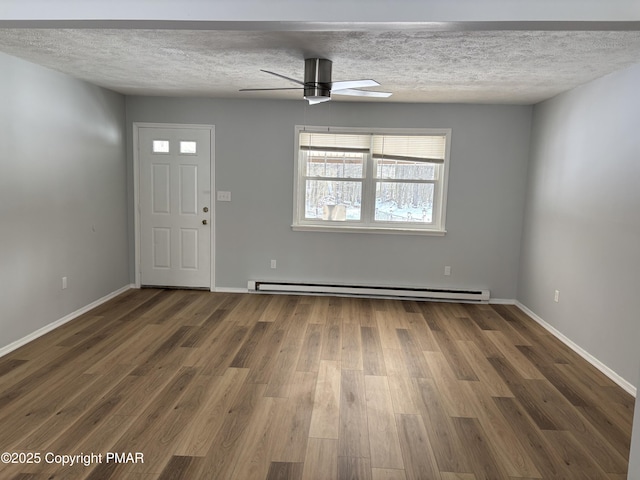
[0,26,640,104]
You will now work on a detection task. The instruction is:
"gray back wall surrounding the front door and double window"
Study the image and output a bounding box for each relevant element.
[127,97,531,299]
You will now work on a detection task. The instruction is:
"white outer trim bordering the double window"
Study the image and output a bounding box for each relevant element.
[291,125,451,236]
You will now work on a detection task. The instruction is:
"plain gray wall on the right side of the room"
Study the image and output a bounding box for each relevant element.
[518,65,640,383]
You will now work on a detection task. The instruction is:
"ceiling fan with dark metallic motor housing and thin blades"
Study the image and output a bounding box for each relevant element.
[240,58,391,105]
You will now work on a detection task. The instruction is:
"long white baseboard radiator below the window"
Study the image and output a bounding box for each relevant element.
[248,280,489,303]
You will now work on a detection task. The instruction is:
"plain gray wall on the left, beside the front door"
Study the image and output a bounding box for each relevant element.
[0,54,129,348]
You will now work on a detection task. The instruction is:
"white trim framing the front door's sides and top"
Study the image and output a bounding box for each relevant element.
[133,122,216,292]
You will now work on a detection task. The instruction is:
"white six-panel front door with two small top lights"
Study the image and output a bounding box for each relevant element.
[138,127,212,288]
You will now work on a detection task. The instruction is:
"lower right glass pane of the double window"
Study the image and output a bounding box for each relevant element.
[375,182,433,223]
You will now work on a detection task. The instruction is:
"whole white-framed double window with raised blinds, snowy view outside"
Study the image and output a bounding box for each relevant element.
[293,127,451,235]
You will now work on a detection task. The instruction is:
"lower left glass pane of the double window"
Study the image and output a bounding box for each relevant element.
[305,180,362,221]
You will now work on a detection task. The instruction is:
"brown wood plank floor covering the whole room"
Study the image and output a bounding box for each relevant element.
[0,289,634,480]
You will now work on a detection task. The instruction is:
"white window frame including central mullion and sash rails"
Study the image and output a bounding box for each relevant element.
[291,125,451,236]
